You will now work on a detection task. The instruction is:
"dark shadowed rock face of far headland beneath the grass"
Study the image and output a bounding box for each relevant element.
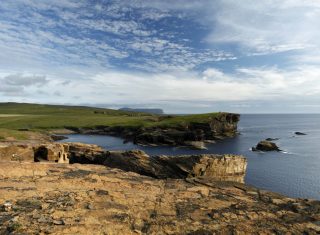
[75,113,240,147]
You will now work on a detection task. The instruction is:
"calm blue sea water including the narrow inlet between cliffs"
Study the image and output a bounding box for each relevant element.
[58,114,320,199]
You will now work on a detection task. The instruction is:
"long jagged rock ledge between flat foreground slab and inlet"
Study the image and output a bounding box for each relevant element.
[0,143,247,182]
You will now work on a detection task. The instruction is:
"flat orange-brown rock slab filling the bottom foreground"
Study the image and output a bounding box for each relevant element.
[0,162,320,234]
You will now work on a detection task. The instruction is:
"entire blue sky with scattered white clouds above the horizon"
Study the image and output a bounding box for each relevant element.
[0,0,320,113]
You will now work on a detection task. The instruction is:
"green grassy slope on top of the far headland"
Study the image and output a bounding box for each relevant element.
[0,103,218,130]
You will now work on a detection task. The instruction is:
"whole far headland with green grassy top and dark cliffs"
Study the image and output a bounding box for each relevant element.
[0,103,240,148]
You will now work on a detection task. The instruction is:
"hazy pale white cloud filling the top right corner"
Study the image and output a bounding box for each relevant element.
[207,0,320,54]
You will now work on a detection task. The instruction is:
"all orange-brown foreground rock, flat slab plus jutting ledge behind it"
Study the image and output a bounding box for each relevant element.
[0,143,320,235]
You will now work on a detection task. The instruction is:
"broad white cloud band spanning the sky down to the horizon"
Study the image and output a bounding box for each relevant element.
[0,66,320,112]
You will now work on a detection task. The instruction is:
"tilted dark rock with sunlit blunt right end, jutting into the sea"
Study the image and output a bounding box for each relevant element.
[103,150,247,182]
